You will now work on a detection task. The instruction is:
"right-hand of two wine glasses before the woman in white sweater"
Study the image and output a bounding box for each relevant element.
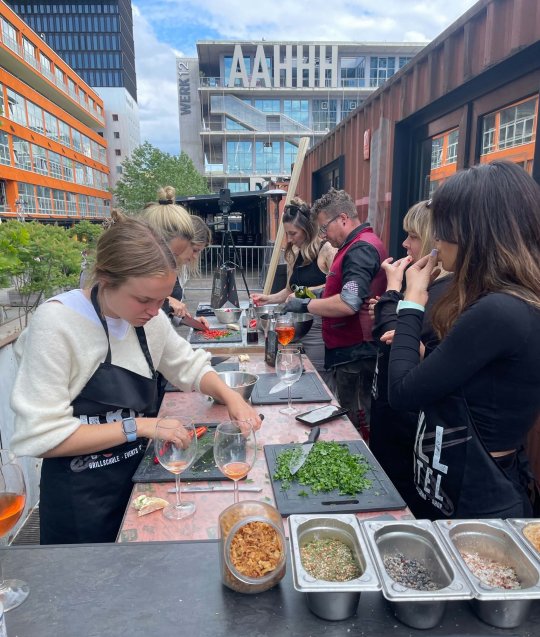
[214,420,257,503]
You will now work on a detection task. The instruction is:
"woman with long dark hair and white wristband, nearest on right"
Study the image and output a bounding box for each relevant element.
[389,162,540,518]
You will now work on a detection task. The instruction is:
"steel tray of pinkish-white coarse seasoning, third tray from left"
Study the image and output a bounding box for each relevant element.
[435,520,540,628]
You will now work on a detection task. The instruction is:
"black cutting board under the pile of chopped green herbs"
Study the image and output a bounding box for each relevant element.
[264,440,406,515]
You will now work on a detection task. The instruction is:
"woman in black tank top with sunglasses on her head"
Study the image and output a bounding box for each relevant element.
[252,197,336,386]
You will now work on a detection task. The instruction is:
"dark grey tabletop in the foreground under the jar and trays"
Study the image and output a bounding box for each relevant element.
[0,541,540,637]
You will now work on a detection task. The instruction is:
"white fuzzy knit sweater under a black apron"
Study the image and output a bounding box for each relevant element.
[10,290,212,457]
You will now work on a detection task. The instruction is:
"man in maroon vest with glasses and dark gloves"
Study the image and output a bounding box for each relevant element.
[285,188,388,439]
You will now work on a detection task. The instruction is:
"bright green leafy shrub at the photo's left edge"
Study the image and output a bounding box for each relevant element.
[0,221,81,325]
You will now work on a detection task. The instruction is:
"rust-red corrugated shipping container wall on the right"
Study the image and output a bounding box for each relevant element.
[298,0,540,253]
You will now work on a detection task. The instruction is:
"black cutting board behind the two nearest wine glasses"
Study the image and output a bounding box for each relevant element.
[132,422,232,482]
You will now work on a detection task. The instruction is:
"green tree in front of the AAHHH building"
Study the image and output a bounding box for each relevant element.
[114,142,210,213]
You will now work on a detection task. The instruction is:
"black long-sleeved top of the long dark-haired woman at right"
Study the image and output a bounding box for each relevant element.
[388,293,540,451]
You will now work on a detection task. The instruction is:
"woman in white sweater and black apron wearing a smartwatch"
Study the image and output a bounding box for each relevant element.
[11,207,261,544]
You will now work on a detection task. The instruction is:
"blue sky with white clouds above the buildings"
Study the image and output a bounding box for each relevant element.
[132,0,476,155]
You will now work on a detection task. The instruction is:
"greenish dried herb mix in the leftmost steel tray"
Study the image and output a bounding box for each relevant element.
[300,538,362,582]
